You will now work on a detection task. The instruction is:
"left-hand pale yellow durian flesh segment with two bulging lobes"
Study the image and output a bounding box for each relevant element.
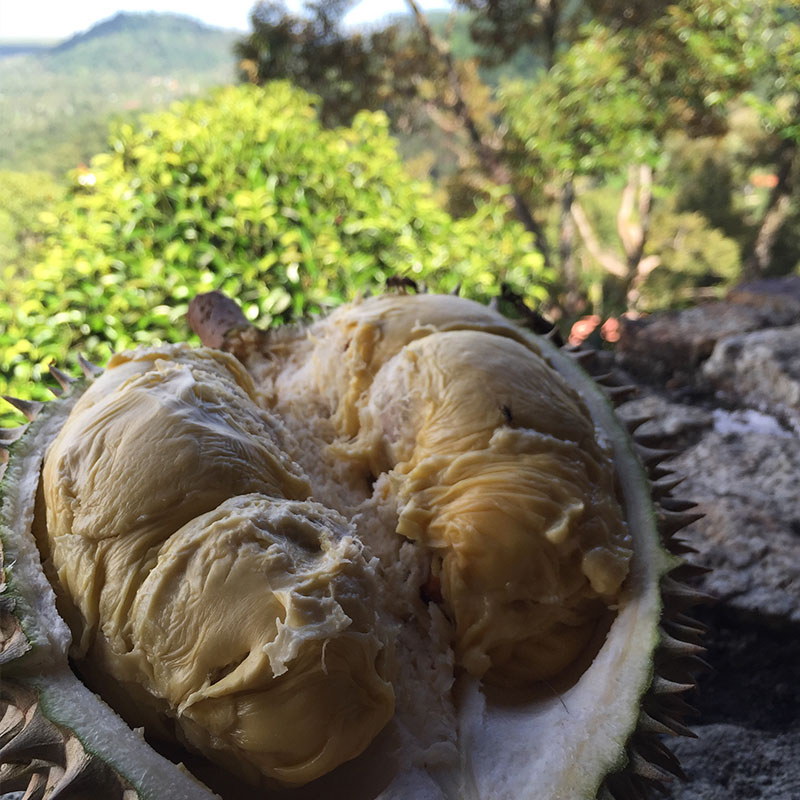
[43,347,394,784]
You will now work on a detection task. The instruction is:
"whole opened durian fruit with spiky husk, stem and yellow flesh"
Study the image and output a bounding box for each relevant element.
[0,294,702,800]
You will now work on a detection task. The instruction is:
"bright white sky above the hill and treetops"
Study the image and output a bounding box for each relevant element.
[0,0,452,40]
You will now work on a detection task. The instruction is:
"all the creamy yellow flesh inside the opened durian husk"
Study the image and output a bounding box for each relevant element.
[34,295,631,798]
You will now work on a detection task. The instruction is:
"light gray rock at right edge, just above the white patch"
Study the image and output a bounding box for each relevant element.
[702,325,800,431]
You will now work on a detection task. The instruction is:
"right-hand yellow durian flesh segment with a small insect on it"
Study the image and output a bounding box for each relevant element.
[254,295,631,685]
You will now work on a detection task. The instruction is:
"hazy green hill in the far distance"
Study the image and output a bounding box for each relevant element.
[0,12,240,175]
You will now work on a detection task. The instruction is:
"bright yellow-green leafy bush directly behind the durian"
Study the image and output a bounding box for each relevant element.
[0,83,546,424]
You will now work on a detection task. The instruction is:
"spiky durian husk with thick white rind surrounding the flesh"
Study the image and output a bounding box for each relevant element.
[0,296,705,800]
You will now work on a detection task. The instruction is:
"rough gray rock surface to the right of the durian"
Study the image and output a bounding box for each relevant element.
[616,283,800,800]
